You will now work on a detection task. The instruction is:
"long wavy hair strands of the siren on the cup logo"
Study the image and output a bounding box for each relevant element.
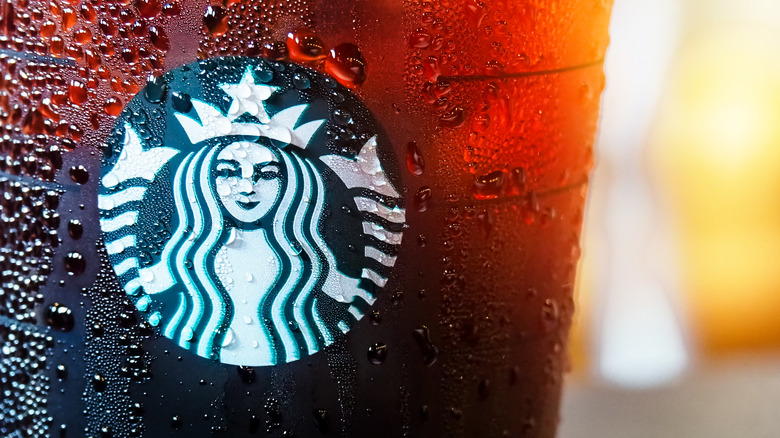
[163,139,342,362]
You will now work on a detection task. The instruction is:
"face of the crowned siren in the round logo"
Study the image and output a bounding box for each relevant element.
[215,141,282,223]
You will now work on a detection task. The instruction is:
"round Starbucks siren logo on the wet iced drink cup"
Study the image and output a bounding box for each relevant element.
[98,57,405,366]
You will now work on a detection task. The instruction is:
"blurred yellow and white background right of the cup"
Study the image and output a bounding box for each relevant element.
[560,0,780,438]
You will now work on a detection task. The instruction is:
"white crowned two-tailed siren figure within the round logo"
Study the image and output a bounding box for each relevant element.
[99,65,404,366]
